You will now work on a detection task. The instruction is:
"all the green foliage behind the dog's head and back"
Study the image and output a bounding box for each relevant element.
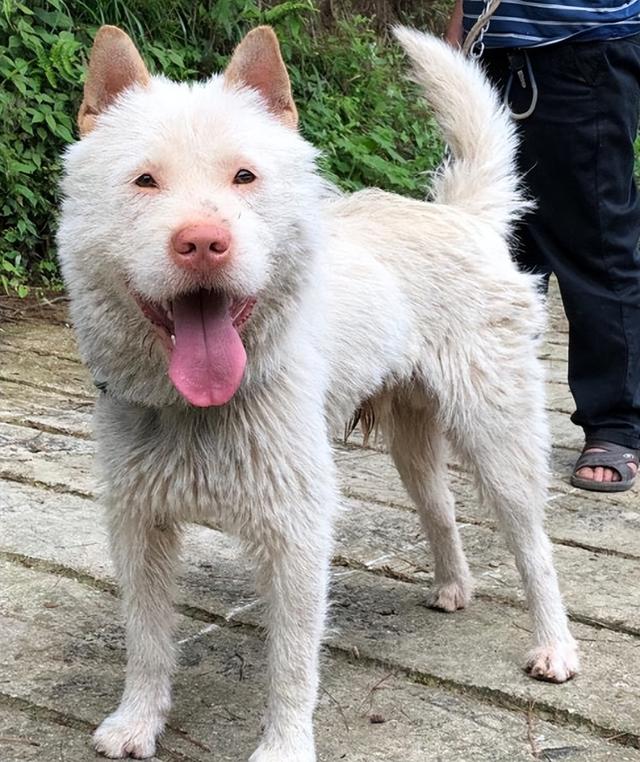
[0,0,440,296]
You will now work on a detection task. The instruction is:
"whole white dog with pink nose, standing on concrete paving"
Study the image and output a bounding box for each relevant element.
[59,27,578,762]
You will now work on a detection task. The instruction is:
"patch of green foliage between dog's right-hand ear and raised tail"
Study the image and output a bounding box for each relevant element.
[280,17,441,196]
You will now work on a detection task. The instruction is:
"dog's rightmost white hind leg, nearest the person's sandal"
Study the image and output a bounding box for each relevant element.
[450,359,578,682]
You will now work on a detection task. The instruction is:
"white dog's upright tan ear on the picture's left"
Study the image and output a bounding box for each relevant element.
[78,26,149,135]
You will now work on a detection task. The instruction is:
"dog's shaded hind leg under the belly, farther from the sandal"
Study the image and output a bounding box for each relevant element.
[378,397,473,611]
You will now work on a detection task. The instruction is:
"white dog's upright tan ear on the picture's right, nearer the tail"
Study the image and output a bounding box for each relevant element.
[224,26,298,129]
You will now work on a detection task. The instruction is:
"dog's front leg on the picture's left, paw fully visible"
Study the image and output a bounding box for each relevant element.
[94,509,179,759]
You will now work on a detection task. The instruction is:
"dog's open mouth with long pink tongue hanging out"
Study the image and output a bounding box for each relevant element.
[134,289,256,407]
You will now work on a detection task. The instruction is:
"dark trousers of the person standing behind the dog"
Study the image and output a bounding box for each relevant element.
[485,35,640,448]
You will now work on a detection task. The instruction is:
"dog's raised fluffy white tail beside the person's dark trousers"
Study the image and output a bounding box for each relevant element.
[393,26,528,236]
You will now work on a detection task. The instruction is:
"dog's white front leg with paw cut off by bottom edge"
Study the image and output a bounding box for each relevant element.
[250,505,331,762]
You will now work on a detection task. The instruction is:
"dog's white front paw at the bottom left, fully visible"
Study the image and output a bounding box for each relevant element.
[93,712,164,759]
